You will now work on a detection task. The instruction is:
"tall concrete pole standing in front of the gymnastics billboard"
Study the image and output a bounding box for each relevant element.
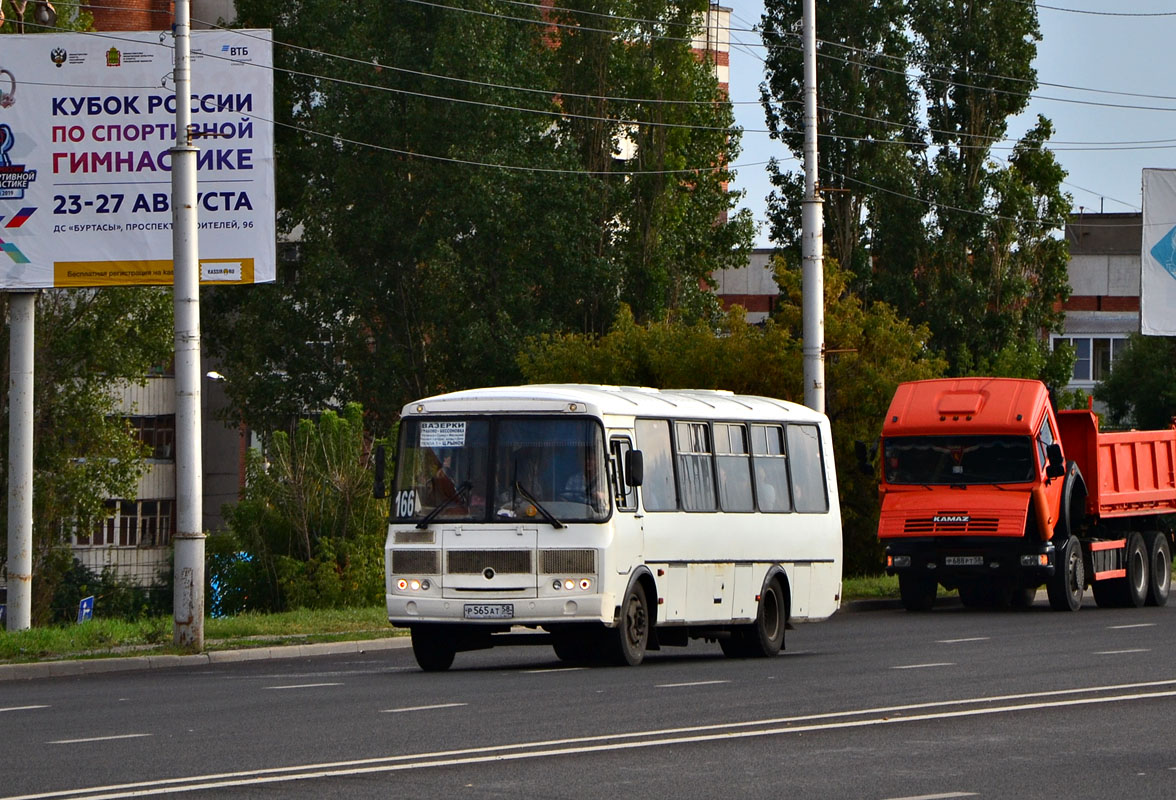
[172,0,205,651]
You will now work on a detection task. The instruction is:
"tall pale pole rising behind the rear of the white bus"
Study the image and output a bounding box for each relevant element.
[801,0,824,413]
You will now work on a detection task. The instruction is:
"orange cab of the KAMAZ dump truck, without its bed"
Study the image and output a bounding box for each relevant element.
[878,378,1084,609]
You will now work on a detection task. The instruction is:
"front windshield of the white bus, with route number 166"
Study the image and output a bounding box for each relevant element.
[392,416,612,522]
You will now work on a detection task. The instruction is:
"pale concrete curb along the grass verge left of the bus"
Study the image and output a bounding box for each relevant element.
[0,636,412,681]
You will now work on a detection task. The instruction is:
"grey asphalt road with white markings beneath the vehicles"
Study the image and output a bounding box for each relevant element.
[0,604,1176,800]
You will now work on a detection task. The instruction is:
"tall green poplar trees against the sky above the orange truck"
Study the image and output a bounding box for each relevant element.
[764,0,1070,380]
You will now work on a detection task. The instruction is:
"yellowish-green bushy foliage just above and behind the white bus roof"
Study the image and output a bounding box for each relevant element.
[520,259,946,574]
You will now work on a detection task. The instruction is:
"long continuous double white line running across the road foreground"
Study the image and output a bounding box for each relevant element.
[18,680,1176,800]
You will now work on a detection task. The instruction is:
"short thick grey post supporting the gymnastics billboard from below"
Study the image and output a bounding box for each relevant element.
[5,292,36,631]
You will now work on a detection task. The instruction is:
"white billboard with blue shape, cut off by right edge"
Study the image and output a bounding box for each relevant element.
[1140,169,1176,336]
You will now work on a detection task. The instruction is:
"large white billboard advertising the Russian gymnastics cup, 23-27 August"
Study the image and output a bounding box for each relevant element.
[0,31,275,289]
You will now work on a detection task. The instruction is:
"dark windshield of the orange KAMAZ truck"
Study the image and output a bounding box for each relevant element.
[882,436,1034,485]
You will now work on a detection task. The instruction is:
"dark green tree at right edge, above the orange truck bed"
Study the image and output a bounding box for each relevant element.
[1095,334,1176,429]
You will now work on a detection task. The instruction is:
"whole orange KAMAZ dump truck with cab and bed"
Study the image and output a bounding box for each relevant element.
[878,378,1176,611]
